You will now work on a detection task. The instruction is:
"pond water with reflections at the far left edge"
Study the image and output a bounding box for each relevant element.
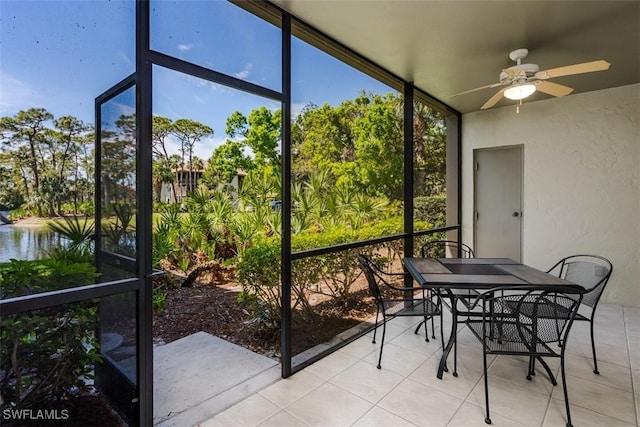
[0,224,67,262]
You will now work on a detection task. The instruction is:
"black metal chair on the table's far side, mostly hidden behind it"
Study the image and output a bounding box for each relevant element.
[420,240,478,377]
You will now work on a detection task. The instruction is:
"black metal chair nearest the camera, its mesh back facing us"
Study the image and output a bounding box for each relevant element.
[467,286,582,427]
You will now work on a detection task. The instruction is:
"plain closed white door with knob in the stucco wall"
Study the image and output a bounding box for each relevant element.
[474,146,524,261]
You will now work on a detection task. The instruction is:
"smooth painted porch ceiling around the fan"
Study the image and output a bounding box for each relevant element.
[271,0,640,113]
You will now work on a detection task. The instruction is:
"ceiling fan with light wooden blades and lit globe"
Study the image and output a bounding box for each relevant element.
[452,49,611,110]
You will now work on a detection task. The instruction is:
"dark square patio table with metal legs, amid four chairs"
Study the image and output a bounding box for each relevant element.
[402,258,585,379]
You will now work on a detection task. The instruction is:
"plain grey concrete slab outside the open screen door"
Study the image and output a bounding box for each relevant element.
[153,332,281,427]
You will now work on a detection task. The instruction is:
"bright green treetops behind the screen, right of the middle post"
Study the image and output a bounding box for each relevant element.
[291,92,446,200]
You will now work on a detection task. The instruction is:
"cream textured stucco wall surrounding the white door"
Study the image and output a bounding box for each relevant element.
[462,84,640,307]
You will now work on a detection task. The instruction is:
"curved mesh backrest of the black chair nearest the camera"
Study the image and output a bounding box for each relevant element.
[482,289,582,346]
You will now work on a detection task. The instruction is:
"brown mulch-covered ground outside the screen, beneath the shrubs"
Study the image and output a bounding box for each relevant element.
[153,270,375,359]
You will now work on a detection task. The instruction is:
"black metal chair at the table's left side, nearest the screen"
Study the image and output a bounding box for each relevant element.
[357,255,440,369]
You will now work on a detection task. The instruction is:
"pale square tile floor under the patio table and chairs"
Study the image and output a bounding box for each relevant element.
[200,304,640,427]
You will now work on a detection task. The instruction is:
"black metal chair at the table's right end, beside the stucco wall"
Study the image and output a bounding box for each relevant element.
[547,255,613,374]
